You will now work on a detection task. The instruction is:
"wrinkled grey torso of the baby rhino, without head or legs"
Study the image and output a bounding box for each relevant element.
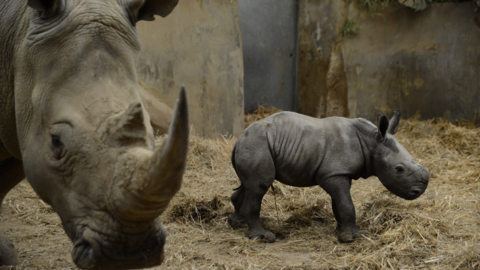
[232,112,363,188]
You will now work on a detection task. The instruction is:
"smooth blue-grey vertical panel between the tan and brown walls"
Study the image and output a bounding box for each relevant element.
[238,0,298,111]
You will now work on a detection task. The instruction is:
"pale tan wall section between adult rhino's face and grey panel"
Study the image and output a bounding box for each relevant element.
[137,0,244,137]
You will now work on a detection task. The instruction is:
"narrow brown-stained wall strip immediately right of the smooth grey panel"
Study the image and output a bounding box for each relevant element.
[297,0,345,117]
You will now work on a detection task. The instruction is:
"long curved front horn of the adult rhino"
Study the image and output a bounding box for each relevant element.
[110,86,190,223]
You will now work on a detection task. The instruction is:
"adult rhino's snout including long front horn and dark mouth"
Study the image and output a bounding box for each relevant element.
[68,87,190,269]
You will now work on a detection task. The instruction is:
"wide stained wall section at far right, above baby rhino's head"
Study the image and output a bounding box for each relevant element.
[344,2,480,121]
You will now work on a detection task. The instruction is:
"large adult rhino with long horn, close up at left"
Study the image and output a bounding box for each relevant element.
[0,0,189,269]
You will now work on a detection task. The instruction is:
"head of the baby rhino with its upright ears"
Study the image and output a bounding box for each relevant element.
[373,111,430,200]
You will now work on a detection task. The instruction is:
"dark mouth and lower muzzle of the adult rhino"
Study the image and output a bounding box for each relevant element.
[72,225,166,269]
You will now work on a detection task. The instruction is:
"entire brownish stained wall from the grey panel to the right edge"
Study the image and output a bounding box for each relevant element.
[297,0,480,123]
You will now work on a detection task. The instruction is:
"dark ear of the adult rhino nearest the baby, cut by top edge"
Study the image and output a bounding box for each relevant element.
[130,0,178,22]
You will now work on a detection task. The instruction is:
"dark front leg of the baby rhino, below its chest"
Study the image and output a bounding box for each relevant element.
[320,177,363,243]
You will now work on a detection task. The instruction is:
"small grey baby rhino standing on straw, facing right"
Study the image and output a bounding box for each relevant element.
[228,111,430,242]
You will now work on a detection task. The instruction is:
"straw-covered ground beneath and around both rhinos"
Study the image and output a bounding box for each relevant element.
[0,113,480,269]
